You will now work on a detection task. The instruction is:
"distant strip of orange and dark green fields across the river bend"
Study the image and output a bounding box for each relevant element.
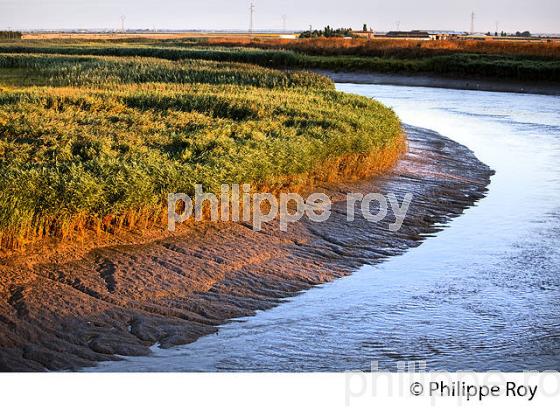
[0,36,560,83]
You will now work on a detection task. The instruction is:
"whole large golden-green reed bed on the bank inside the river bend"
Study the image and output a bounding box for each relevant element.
[0,52,403,247]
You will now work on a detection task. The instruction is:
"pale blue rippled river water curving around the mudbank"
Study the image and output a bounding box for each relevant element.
[89,84,560,371]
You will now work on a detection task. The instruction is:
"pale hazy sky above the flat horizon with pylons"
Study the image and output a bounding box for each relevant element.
[0,0,560,33]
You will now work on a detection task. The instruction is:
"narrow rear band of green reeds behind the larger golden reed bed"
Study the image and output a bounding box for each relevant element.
[0,54,333,88]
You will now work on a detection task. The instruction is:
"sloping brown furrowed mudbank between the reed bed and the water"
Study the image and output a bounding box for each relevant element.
[0,127,492,371]
